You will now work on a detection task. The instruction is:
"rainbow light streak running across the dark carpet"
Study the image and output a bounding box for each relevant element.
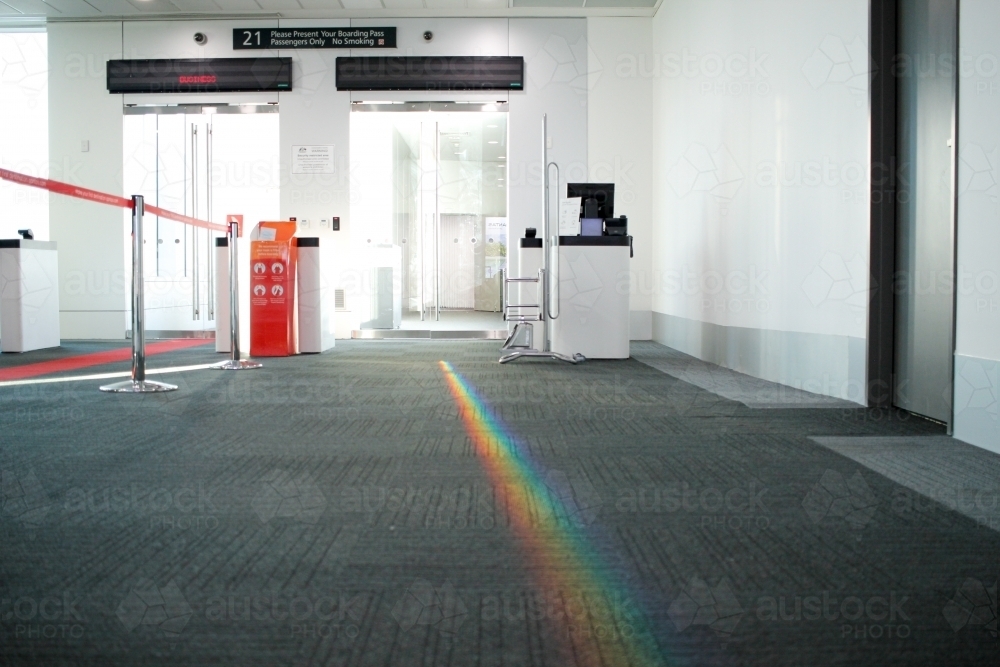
[440,361,665,667]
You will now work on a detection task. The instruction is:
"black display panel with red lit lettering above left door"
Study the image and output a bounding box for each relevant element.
[108,58,292,93]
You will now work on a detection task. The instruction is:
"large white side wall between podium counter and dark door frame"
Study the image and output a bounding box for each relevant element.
[648,0,869,402]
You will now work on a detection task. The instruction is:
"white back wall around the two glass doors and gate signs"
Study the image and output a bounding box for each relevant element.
[50,18,588,338]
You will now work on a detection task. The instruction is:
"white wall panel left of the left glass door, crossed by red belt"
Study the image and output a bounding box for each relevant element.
[48,22,128,339]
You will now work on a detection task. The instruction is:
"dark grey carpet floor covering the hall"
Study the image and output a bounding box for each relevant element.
[0,341,1000,667]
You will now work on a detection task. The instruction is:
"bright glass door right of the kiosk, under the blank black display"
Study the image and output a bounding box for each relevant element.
[351,103,507,330]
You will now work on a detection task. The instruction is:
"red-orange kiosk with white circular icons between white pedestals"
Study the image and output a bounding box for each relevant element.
[250,221,298,357]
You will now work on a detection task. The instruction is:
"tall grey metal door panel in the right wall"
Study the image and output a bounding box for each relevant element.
[894,0,958,422]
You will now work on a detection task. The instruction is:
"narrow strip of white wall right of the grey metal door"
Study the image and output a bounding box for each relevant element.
[955,0,1000,452]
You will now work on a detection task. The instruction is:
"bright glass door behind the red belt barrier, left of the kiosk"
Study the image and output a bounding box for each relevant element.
[123,106,279,336]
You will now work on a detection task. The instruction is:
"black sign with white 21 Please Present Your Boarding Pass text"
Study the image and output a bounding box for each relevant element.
[233,28,396,50]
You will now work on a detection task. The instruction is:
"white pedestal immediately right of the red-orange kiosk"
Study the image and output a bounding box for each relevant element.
[296,237,336,354]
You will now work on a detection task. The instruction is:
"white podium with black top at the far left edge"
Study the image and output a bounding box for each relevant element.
[0,239,59,352]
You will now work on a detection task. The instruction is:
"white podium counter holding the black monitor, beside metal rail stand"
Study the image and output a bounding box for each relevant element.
[519,236,631,359]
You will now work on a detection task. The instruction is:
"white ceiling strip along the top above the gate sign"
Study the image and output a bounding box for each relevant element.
[0,0,660,20]
